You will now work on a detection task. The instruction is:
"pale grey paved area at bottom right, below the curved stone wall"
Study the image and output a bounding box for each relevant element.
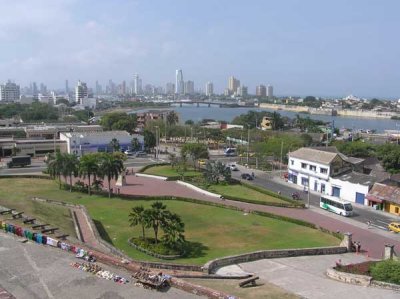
[217,254,399,299]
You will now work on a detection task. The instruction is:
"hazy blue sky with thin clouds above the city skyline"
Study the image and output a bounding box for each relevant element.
[0,0,400,98]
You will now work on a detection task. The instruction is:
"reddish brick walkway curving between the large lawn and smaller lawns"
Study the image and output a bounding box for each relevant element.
[70,175,400,258]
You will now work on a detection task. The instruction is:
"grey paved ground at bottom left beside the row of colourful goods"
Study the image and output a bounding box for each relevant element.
[0,232,199,299]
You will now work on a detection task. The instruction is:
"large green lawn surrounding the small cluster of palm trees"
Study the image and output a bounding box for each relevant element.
[0,179,339,264]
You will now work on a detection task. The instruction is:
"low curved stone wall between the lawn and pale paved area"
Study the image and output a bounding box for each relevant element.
[203,246,347,273]
